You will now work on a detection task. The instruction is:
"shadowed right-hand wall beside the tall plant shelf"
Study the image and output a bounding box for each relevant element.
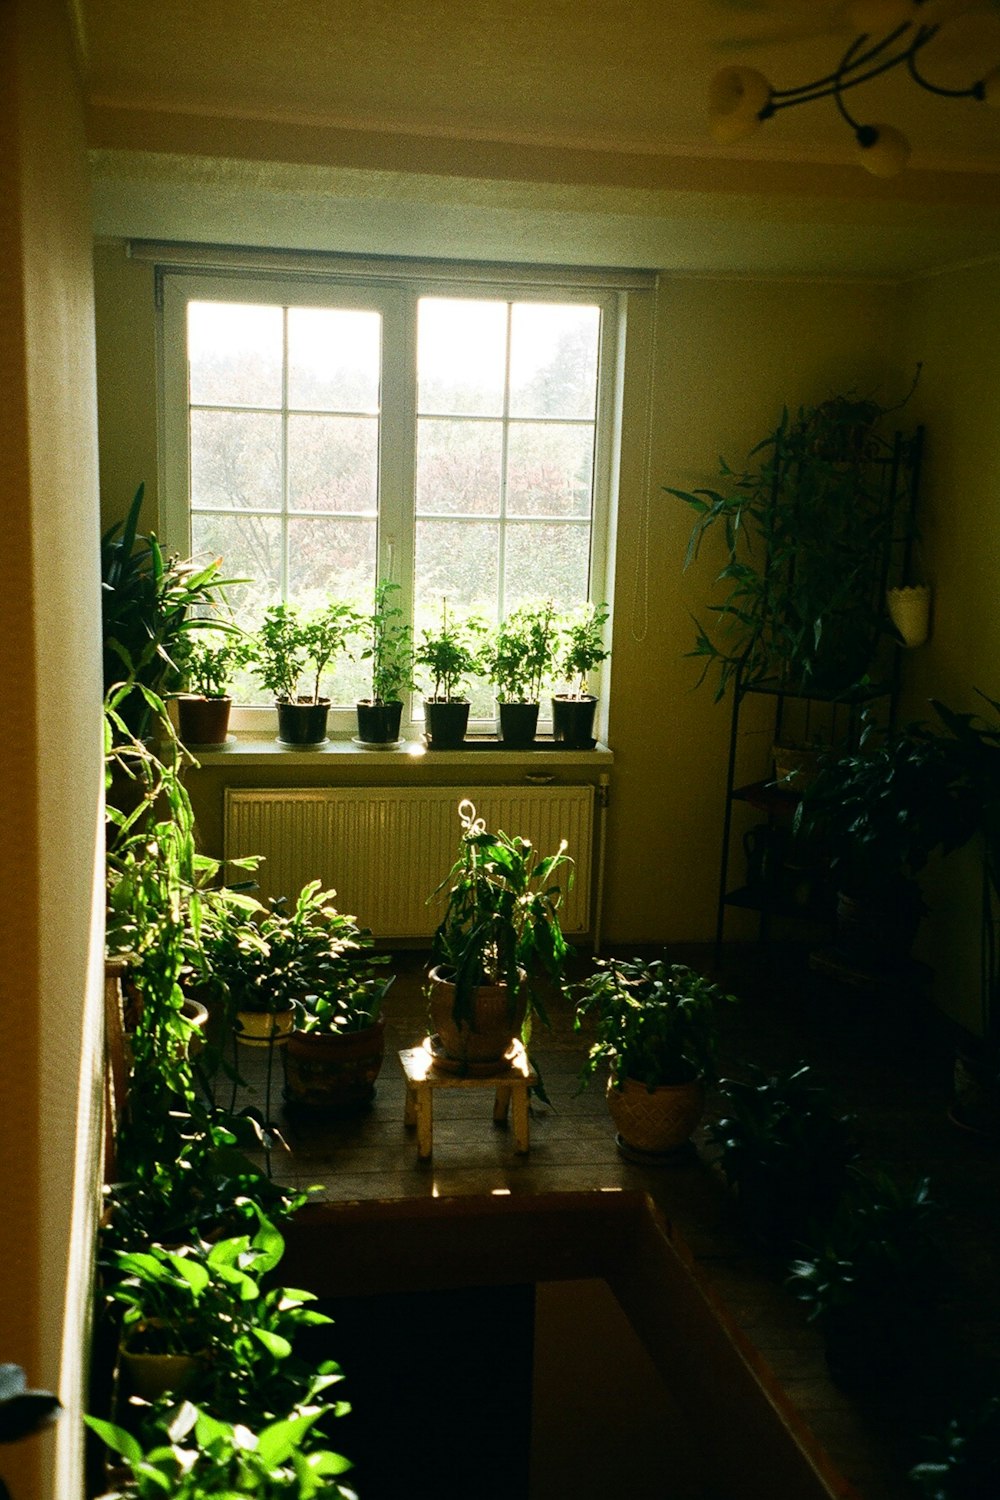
[903,263,1000,1029]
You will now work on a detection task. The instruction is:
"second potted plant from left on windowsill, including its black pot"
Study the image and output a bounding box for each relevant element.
[247,600,358,749]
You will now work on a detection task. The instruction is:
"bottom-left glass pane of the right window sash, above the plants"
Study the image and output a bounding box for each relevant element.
[414,521,499,629]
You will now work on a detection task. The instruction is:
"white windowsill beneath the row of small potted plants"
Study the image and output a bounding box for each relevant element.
[183,734,615,771]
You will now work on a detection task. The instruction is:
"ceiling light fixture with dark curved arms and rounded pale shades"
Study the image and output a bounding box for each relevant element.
[709,0,1000,177]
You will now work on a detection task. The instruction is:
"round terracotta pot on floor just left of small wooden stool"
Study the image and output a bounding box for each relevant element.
[285,1017,385,1115]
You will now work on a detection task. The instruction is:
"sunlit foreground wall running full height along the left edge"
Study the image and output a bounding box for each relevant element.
[0,0,103,1500]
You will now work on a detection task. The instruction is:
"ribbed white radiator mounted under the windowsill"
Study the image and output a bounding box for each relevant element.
[225,786,594,938]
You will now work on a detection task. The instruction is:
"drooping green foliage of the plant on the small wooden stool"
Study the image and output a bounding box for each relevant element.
[432,801,573,1026]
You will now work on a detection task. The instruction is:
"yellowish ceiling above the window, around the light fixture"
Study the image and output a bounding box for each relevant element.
[78,0,1000,276]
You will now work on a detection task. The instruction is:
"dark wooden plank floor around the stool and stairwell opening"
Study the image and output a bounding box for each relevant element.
[229,948,1000,1500]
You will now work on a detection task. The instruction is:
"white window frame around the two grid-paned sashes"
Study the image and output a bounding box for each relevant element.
[160,248,629,738]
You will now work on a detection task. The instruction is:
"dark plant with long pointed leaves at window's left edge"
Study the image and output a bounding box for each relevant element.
[100,485,240,738]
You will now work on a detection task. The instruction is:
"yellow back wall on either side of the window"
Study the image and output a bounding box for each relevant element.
[96,245,909,942]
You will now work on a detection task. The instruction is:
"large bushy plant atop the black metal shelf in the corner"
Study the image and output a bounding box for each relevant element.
[664,381,919,698]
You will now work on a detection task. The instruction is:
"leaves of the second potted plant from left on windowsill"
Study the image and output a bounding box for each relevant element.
[246,600,360,704]
